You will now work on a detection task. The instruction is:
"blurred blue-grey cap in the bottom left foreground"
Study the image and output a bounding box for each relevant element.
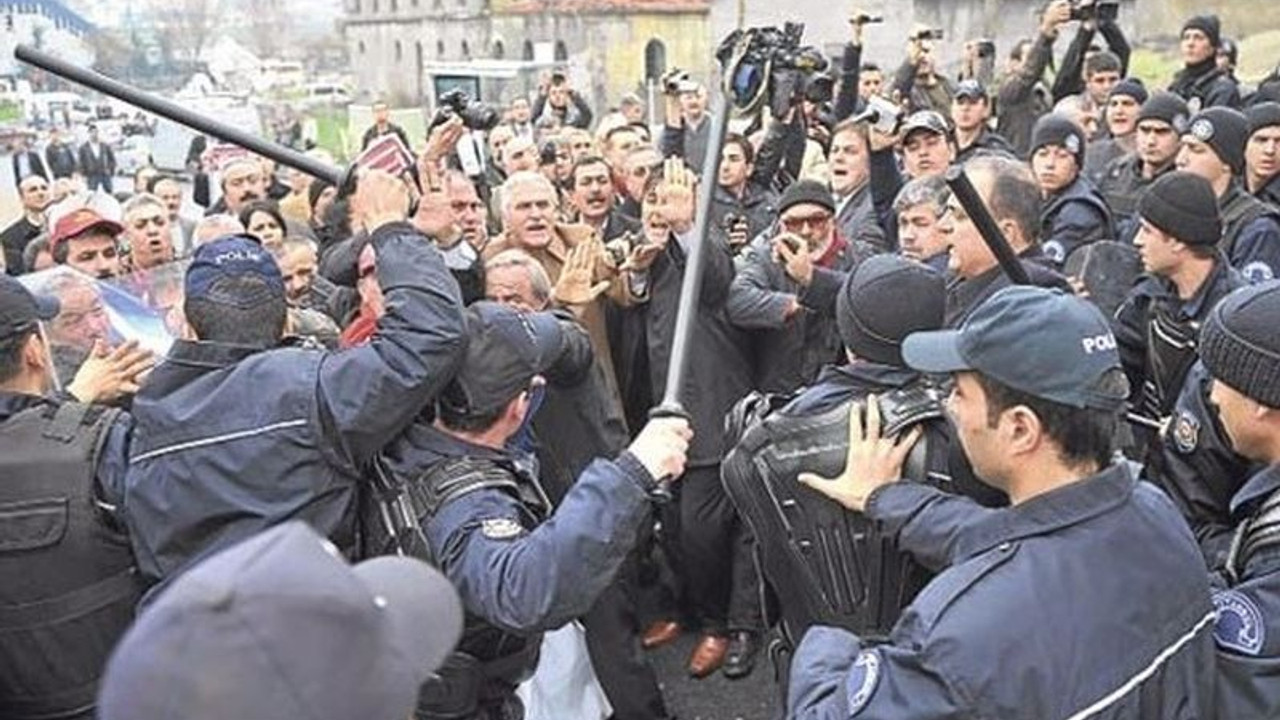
[99,520,462,720]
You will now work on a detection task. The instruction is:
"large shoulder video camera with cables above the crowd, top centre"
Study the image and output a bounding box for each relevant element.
[716,22,828,118]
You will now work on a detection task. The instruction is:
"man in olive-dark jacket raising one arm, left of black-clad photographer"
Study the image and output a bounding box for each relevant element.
[996,0,1071,156]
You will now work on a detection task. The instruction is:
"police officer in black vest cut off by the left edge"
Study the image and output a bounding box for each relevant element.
[0,274,151,720]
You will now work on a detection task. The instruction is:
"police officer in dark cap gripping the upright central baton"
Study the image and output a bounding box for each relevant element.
[384,301,691,720]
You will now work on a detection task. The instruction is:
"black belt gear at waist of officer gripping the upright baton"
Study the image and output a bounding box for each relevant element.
[415,638,541,720]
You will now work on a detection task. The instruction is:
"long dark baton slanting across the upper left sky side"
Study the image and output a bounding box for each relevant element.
[13,45,349,188]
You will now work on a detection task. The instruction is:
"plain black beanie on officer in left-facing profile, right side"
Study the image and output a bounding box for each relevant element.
[1138,170,1222,245]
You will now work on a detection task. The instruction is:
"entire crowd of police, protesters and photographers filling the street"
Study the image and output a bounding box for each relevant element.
[0,0,1280,720]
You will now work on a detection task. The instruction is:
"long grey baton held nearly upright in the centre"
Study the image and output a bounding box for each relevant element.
[649,88,730,500]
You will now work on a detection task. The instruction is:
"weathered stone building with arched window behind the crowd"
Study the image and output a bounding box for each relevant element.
[343,0,713,109]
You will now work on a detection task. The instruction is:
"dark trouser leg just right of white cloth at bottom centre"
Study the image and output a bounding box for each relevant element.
[582,553,667,720]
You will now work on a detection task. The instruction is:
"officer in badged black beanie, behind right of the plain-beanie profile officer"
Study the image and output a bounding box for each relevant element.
[1178,108,1280,282]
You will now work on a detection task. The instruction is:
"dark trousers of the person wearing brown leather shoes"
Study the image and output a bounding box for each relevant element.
[667,465,763,633]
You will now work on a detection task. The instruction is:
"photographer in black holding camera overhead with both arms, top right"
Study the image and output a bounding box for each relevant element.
[1053,0,1130,108]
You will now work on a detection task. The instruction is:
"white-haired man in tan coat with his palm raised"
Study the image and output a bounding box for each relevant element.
[484,172,632,392]
